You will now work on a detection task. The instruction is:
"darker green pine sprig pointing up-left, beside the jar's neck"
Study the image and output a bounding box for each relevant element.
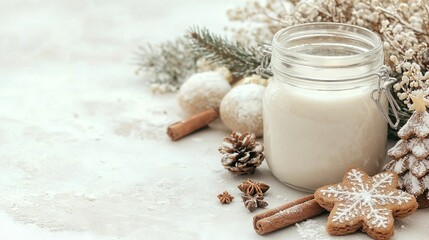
[189,27,262,78]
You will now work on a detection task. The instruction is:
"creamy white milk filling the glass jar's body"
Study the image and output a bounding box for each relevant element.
[263,80,387,191]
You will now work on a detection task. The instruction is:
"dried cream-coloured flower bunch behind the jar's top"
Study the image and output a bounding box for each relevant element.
[228,0,429,108]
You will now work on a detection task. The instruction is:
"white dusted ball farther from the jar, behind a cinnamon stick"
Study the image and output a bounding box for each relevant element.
[177,71,231,115]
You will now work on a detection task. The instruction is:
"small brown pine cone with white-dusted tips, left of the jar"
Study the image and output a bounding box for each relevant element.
[219,132,265,175]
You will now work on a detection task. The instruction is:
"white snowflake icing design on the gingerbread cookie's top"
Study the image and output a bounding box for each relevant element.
[321,169,412,228]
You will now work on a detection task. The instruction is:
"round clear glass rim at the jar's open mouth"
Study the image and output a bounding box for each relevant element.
[272,22,382,60]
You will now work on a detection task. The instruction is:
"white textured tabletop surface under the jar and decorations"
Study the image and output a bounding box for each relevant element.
[0,0,429,240]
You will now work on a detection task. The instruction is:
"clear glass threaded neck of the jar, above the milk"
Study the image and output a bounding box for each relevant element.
[271,23,384,88]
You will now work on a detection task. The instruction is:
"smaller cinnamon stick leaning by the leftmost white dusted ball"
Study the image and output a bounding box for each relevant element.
[167,109,219,141]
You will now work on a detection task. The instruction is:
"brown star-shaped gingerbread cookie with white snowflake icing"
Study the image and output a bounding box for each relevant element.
[314,168,417,239]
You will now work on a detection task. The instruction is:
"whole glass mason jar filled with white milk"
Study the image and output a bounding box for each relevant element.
[263,23,388,192]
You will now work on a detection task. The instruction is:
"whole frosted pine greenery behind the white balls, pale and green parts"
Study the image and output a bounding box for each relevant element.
[137,28,262,92]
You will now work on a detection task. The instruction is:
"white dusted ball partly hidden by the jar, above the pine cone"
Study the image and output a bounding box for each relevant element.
[220,83,265,137]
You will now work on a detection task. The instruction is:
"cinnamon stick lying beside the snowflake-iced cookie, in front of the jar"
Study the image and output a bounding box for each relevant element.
[253,194,326,235]
